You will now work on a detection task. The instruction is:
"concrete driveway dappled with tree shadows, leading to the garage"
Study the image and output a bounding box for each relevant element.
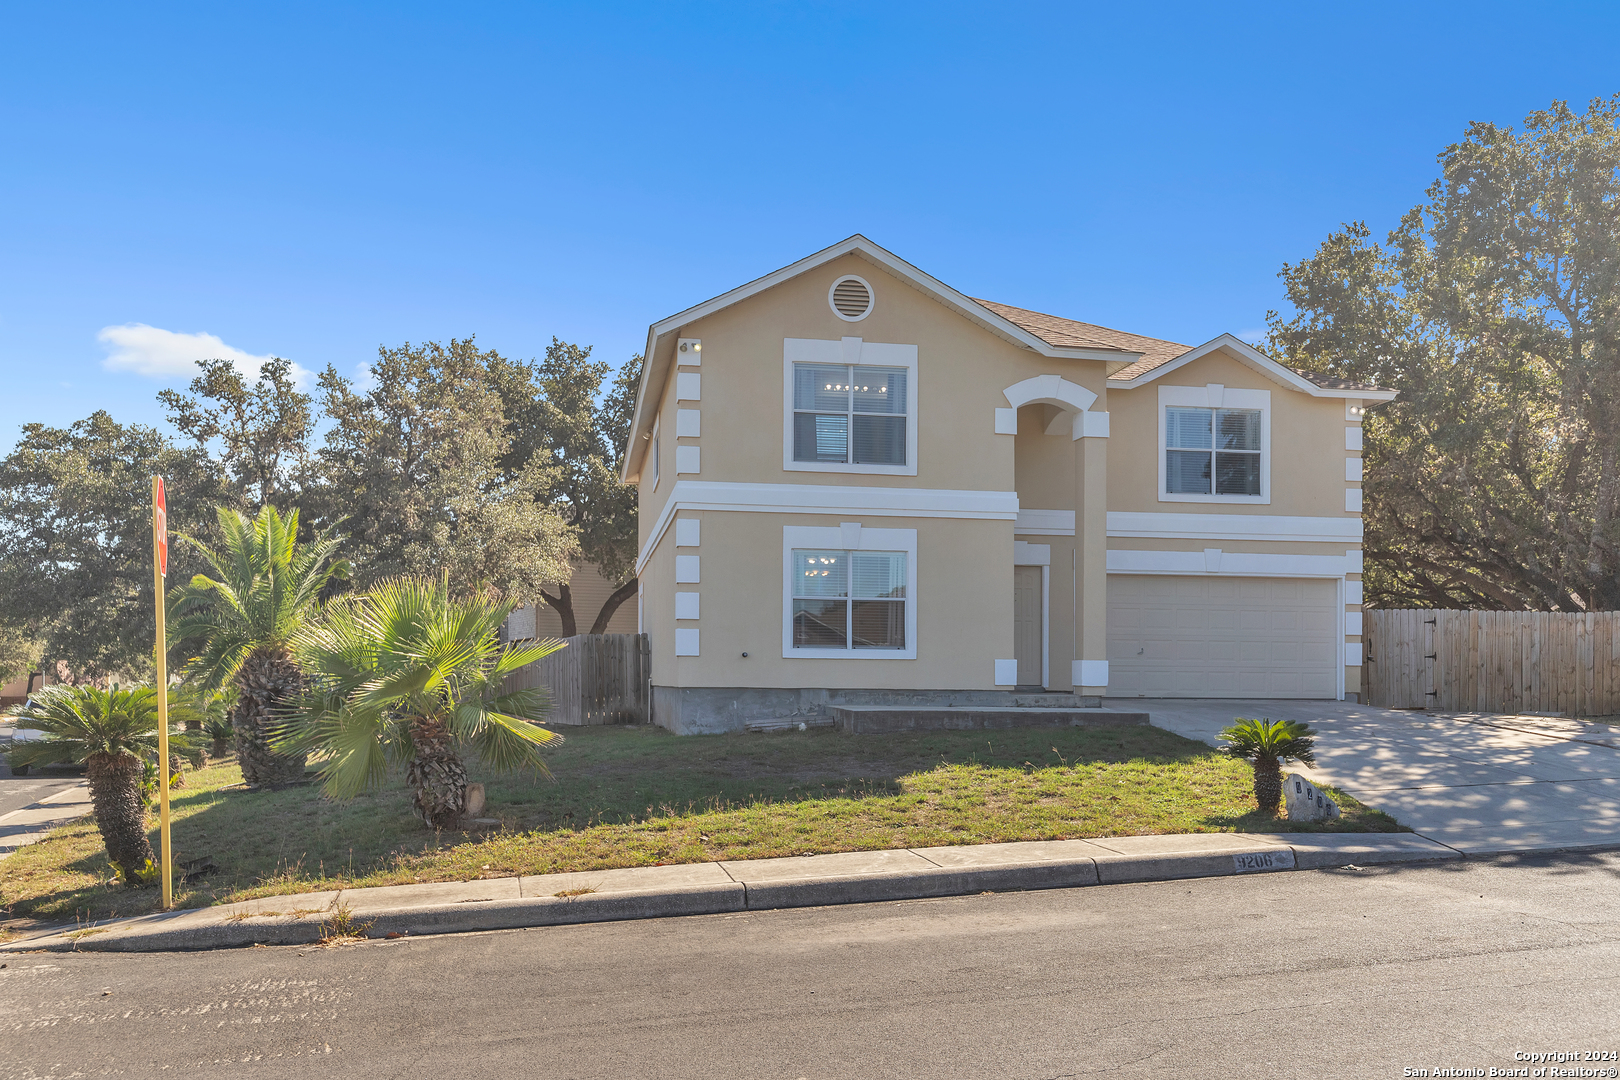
[1105,698,1620,855]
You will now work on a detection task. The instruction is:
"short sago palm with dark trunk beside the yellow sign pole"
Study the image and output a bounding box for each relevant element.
[10,685,193,884]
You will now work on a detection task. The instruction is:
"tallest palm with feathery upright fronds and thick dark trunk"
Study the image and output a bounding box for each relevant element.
[170,507,348,785]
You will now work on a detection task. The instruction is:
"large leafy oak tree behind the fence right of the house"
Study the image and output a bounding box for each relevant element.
[1268,96,1620,610]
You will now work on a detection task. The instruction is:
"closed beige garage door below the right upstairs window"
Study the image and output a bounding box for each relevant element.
[1108,573,1341,698]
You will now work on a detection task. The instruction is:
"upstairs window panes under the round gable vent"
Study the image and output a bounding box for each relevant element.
[792,364,909,465]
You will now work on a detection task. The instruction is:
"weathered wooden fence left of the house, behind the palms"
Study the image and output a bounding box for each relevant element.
[505,633,653,727]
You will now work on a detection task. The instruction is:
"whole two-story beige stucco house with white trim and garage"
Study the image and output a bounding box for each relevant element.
[624,236,1395,732]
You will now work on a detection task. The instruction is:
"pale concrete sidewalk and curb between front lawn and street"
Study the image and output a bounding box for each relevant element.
[0,832,1461,952]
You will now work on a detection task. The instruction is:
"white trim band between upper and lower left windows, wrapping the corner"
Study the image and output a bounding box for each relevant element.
[635,479,1017,576]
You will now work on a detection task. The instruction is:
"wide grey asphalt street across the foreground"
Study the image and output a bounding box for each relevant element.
[0,853,1620,1080]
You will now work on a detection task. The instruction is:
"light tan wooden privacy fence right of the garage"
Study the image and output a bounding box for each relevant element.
[1362,610,1620,716]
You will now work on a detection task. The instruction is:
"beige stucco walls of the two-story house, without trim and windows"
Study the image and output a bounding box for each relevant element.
[627,247,1359,702]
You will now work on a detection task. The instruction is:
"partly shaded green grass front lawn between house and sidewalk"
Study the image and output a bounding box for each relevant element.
[0,727,1400,921]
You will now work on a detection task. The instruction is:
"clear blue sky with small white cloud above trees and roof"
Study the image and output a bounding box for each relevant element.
[0,0,1620,449]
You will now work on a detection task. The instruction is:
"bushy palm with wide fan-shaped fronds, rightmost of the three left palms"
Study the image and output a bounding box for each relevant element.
[288,578,562,829]
